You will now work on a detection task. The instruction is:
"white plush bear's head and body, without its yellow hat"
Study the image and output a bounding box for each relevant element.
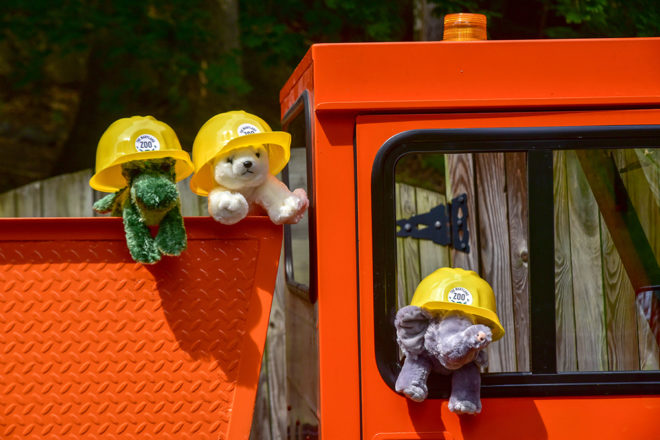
[209,145,309,225]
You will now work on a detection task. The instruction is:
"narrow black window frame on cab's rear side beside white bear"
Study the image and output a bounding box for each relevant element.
[282,90,318,304]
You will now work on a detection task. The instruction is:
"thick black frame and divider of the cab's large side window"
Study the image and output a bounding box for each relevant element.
[371,125,660,399]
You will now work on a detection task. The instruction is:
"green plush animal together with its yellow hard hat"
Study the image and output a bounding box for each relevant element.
[90,116,192,263]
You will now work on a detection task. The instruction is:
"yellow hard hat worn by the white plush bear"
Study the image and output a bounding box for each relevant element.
[190,110,291,196]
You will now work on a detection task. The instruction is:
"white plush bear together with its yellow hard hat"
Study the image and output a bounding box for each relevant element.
[190,111,309,225]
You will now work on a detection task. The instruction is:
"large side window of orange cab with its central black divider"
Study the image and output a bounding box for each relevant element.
[372,129,660,395]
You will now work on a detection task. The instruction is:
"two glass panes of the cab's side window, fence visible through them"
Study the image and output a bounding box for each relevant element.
[394,148,660,373]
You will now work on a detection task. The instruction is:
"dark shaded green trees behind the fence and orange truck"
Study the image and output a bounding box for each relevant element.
[0,0,660,183]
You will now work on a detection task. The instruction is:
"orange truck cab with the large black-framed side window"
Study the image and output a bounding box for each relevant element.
[280,38,660,440]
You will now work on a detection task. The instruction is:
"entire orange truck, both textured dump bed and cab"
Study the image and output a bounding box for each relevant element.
[0,25,660,440]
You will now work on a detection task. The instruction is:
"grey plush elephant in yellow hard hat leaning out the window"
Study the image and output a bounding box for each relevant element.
[394,268,504,414]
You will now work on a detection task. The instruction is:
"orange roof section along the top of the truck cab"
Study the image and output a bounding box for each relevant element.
[280,38,660,114]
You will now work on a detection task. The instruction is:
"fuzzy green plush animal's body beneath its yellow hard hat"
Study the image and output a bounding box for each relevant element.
[94,159,187,263]
